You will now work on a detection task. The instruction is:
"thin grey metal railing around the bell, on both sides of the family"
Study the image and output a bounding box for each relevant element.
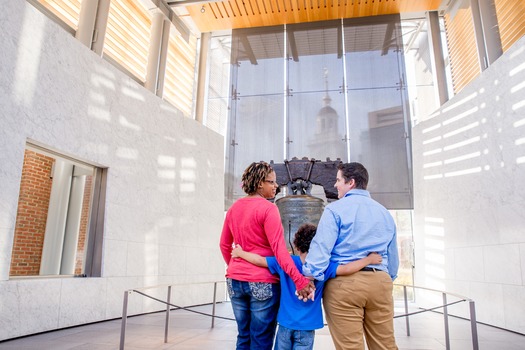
[119,281,479,350]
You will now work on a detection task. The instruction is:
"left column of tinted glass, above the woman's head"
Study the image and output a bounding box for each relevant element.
[226,26,284,205]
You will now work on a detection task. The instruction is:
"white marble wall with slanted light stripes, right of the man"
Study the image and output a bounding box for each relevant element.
[413,37,525,333]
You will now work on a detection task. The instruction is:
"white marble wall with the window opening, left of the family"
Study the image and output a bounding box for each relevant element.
[0,1,224,340]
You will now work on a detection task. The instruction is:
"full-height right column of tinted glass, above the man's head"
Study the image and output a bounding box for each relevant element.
[344,16,413,209]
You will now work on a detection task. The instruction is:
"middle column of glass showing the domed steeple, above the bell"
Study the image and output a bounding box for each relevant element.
[287,21,346,160]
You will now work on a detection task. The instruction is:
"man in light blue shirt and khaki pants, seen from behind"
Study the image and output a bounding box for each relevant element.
[303,163,399,350]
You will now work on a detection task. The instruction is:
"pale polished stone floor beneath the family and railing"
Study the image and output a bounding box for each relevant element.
[0,302,525,350]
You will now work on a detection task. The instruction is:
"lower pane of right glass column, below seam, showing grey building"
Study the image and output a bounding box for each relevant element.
[348,89,412,209]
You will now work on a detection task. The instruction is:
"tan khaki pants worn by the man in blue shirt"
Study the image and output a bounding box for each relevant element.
[323,271,397,350]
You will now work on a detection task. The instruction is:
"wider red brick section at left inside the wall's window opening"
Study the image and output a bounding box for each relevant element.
[9,150,54,276]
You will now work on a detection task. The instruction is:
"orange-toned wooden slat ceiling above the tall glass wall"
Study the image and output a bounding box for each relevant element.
[167,0,444,32]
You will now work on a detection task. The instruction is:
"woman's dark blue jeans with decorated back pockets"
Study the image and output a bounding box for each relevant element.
[227,278,281,350]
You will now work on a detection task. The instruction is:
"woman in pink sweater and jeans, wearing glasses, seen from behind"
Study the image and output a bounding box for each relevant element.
[220,162,313,350]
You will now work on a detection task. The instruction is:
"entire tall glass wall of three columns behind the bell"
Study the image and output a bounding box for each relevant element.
[226,16,412,209]
